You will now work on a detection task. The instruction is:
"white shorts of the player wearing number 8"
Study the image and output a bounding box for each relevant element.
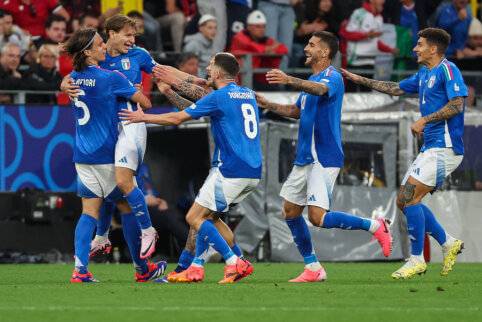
[196,167,259,213]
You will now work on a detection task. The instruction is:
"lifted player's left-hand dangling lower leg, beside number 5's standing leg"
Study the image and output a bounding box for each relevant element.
[90,199,115,257]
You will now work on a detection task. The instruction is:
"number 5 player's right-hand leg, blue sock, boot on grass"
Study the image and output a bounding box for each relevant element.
[116,198,167,282]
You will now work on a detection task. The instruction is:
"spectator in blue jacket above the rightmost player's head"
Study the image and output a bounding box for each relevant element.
[435,0,472,59]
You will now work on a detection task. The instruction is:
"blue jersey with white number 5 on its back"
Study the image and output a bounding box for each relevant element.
[70,65,137,164]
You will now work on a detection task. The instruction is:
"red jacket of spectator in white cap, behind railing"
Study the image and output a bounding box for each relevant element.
[229,30,288,83]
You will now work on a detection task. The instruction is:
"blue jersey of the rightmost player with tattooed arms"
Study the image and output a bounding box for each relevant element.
[398,58,467,154]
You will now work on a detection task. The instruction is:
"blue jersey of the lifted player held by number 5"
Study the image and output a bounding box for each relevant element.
[100,47,157,84]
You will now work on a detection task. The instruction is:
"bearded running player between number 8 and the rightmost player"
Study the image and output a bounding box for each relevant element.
[257,31,392,282]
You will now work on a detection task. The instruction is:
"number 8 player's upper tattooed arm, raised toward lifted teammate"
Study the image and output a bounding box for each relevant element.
[153,66,210,101]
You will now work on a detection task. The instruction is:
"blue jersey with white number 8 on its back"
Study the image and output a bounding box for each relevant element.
[184,83,262,178]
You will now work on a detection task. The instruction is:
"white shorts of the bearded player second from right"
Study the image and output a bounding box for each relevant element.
[280,161,340,210]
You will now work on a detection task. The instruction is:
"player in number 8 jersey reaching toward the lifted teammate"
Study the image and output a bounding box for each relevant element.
[120,53,262,283]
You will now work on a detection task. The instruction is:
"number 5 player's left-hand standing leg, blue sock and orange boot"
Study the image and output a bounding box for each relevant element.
[70,197,103,283]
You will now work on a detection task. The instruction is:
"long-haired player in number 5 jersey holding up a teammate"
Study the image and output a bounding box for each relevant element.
[62,29,166,283]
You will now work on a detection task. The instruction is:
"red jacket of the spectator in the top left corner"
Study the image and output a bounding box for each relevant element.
[0,0,70,37]
